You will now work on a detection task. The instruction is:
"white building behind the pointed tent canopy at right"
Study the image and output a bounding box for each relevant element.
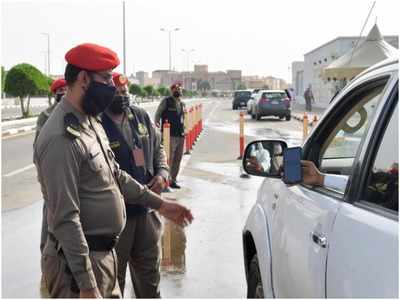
[292,32,399,107]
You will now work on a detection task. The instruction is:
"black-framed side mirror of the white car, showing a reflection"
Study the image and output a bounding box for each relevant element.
[243,140,288,178]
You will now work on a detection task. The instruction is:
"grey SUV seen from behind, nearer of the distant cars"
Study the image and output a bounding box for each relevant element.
[251,90,291,121]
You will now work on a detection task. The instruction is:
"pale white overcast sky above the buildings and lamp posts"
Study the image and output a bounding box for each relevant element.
[0,0,400,81]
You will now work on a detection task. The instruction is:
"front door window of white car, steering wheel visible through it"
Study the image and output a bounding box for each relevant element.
[320,81,387,175]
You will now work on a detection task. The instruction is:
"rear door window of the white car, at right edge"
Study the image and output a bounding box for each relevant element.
[362,105,399,212]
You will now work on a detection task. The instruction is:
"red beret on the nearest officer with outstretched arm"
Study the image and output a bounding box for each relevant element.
[65,43,119,72]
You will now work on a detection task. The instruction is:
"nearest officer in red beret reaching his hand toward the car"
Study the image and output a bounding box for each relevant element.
[34,44,192,298]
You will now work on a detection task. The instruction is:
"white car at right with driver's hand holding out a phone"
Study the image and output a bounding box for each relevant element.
[243,59,399,298]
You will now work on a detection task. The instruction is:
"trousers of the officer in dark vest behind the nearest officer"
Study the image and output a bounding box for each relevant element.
[116,211,162,298]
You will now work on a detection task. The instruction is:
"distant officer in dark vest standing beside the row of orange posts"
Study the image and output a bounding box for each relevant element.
[155,82,185,189]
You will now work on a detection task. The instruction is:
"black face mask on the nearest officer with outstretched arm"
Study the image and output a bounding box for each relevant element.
[82,81,116,117]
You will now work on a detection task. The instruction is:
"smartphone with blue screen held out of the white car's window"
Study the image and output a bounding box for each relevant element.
[283,147,303,184]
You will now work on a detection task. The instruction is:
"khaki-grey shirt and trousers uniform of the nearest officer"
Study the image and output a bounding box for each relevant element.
[34,98,162,298]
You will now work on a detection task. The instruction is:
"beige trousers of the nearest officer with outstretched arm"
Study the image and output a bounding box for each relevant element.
[41,240,122,298]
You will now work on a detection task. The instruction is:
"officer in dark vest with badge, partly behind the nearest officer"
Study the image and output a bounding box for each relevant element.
[102,73,169,298]
